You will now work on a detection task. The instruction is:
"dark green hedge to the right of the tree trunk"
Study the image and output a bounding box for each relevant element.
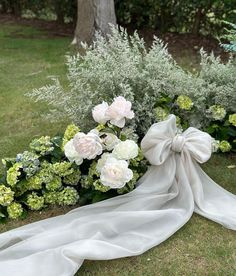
[115,0,236,34]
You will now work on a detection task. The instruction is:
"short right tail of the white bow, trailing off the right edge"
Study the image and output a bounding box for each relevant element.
[185,156,236,230]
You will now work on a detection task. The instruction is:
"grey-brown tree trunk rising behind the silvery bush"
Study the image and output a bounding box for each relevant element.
[72,0,116,44]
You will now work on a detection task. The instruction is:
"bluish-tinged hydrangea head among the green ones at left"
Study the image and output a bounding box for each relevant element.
[16,151,40,177]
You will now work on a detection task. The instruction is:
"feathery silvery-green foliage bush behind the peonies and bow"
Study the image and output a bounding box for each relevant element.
[29,27,236,135]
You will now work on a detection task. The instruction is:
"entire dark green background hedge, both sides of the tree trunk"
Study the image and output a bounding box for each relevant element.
[0,0,236,34]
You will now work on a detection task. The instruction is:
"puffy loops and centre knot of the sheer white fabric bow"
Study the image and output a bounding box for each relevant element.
[141,115,212,165]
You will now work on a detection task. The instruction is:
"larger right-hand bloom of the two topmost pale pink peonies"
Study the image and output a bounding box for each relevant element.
[106,96,134,128]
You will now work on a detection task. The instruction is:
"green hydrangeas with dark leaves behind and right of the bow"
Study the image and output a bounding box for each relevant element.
[155,94,236,152]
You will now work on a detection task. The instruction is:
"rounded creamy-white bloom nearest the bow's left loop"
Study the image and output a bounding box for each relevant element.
[112,140,138,160]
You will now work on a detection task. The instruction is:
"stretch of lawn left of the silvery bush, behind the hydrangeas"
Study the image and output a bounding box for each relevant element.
[0,25,70,162]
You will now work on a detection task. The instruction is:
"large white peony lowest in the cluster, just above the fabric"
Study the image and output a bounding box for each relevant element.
[100,157,133,189]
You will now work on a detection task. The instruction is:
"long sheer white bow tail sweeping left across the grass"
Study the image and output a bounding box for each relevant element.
[0,156,194,276]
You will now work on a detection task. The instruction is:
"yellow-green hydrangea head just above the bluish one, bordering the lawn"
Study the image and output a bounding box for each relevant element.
[30,136,54,156]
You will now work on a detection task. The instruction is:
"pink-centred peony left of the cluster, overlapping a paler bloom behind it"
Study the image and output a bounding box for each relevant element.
[73,131,102,160]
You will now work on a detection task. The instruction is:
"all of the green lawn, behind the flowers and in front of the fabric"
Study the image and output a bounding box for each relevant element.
[0,21,236,276]
